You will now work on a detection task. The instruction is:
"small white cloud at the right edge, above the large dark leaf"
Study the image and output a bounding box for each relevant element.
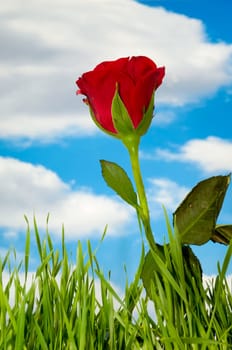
[155,136,232,173]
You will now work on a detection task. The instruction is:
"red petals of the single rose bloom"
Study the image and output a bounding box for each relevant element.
[76,56,165,136]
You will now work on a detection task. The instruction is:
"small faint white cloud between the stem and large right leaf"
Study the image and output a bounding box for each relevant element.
[148,178,189,216]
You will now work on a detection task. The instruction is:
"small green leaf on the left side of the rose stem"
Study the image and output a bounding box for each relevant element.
[100,160,138,208]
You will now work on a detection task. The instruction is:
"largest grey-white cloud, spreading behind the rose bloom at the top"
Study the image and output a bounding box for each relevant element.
[0,0,232,141]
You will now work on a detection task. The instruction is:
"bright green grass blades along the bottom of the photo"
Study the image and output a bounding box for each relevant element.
[0,217,232,350]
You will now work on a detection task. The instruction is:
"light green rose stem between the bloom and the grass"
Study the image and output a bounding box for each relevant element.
[123,135,156,249]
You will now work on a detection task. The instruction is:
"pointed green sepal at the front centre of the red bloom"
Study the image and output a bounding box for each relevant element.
[111,87,135,136]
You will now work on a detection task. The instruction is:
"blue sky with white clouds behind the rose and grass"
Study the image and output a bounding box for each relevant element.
[0,0,232,285]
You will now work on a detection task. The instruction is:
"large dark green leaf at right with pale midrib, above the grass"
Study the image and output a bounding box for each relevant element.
[173,175,230,245]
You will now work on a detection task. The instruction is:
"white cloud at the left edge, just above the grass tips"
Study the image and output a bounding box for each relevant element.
[0,157,132,240]
